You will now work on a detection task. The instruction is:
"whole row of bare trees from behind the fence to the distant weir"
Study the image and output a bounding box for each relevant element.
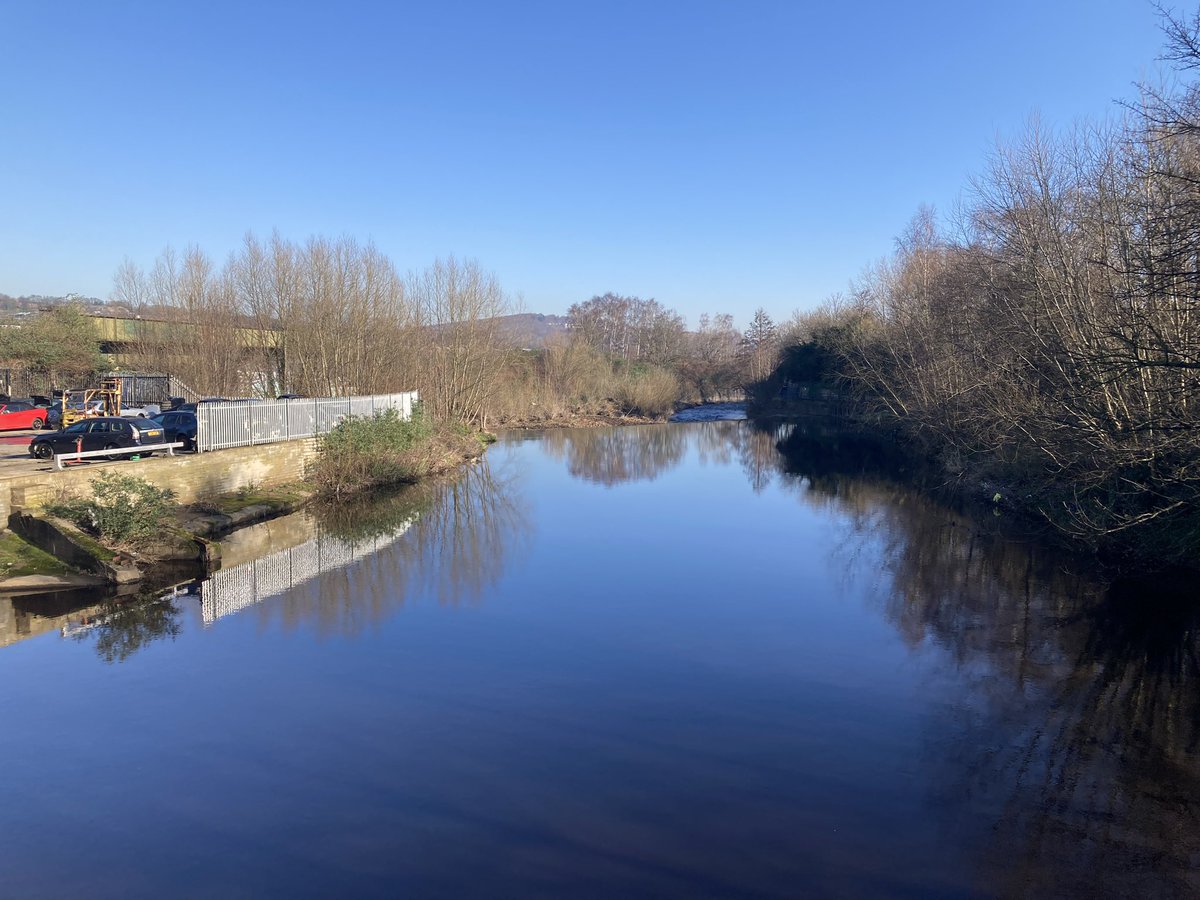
[105,240,776,425]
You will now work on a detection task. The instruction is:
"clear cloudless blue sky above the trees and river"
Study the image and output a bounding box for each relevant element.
[0,0,1162,325]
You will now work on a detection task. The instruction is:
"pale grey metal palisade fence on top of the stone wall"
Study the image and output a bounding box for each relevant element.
[196,391,418,452]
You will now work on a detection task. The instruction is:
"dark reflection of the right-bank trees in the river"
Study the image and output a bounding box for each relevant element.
[763,426,1200,896]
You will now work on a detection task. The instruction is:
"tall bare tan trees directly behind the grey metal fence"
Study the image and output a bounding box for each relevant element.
[113,234,510,421]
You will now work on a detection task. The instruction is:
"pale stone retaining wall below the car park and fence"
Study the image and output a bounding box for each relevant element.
[0,438,317,524]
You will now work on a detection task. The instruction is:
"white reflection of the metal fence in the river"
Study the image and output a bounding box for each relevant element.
[199,516,416,625]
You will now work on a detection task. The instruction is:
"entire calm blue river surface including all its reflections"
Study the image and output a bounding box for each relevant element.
[0,421,1200,898]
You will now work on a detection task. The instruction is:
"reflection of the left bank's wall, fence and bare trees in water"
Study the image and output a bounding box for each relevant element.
[0,460,529,662]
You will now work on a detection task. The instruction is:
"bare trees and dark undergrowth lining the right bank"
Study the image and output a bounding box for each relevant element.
[774,8,1200,559]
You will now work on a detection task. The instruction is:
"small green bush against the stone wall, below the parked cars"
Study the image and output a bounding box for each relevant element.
[46,472,176,545]
